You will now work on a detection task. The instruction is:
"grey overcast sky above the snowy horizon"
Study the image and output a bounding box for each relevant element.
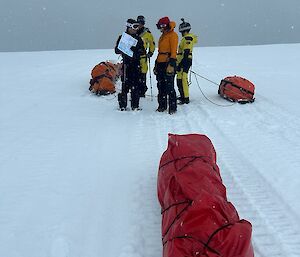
[0,0,300,52]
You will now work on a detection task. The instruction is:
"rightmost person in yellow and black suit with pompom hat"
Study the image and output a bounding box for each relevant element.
[176,19,198,104]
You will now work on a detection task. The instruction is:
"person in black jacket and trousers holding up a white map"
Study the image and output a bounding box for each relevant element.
[115,19,146,111]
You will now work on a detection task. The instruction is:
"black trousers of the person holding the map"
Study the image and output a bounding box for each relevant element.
[118,65,140,109]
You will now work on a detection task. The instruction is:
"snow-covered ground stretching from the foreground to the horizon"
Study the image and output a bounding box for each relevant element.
[0,44,300,257]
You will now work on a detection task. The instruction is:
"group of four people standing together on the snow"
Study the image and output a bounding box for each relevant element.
[115,15,197,114]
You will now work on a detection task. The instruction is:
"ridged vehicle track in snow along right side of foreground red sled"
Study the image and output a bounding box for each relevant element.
[183,99,300,257]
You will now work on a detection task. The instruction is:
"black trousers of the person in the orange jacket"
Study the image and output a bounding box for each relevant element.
[156,62,177,112]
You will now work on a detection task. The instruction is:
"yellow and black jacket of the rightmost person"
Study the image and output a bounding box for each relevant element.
[177,33,198,64]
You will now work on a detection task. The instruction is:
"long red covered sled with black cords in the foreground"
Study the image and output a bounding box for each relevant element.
[157,134,254,257]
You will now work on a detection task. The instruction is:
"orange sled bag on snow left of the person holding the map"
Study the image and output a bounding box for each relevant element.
[89,62,120,95]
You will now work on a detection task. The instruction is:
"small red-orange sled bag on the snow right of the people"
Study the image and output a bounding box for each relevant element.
[218,76,255,103]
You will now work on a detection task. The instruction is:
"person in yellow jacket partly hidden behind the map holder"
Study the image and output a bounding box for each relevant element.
[137,15,155,97]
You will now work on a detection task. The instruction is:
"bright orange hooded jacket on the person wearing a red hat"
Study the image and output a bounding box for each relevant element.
[156,21,178,62]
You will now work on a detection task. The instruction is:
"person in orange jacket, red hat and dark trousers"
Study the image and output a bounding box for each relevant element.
[154,17,178,114]
